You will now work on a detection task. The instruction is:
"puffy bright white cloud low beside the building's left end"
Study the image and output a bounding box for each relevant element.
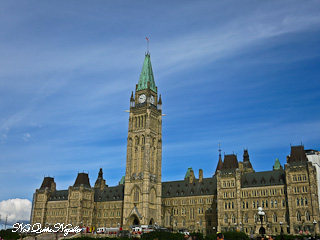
[0,198,31,225]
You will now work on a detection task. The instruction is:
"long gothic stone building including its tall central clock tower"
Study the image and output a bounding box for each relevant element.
[31,53,319,234]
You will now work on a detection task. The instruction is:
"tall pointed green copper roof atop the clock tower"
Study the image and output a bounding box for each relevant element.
[137,53,157,92]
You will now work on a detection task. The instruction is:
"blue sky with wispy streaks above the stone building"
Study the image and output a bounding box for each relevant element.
[0,0,320,224]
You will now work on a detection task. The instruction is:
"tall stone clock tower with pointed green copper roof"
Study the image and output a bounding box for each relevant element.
[123,52,162,228]
